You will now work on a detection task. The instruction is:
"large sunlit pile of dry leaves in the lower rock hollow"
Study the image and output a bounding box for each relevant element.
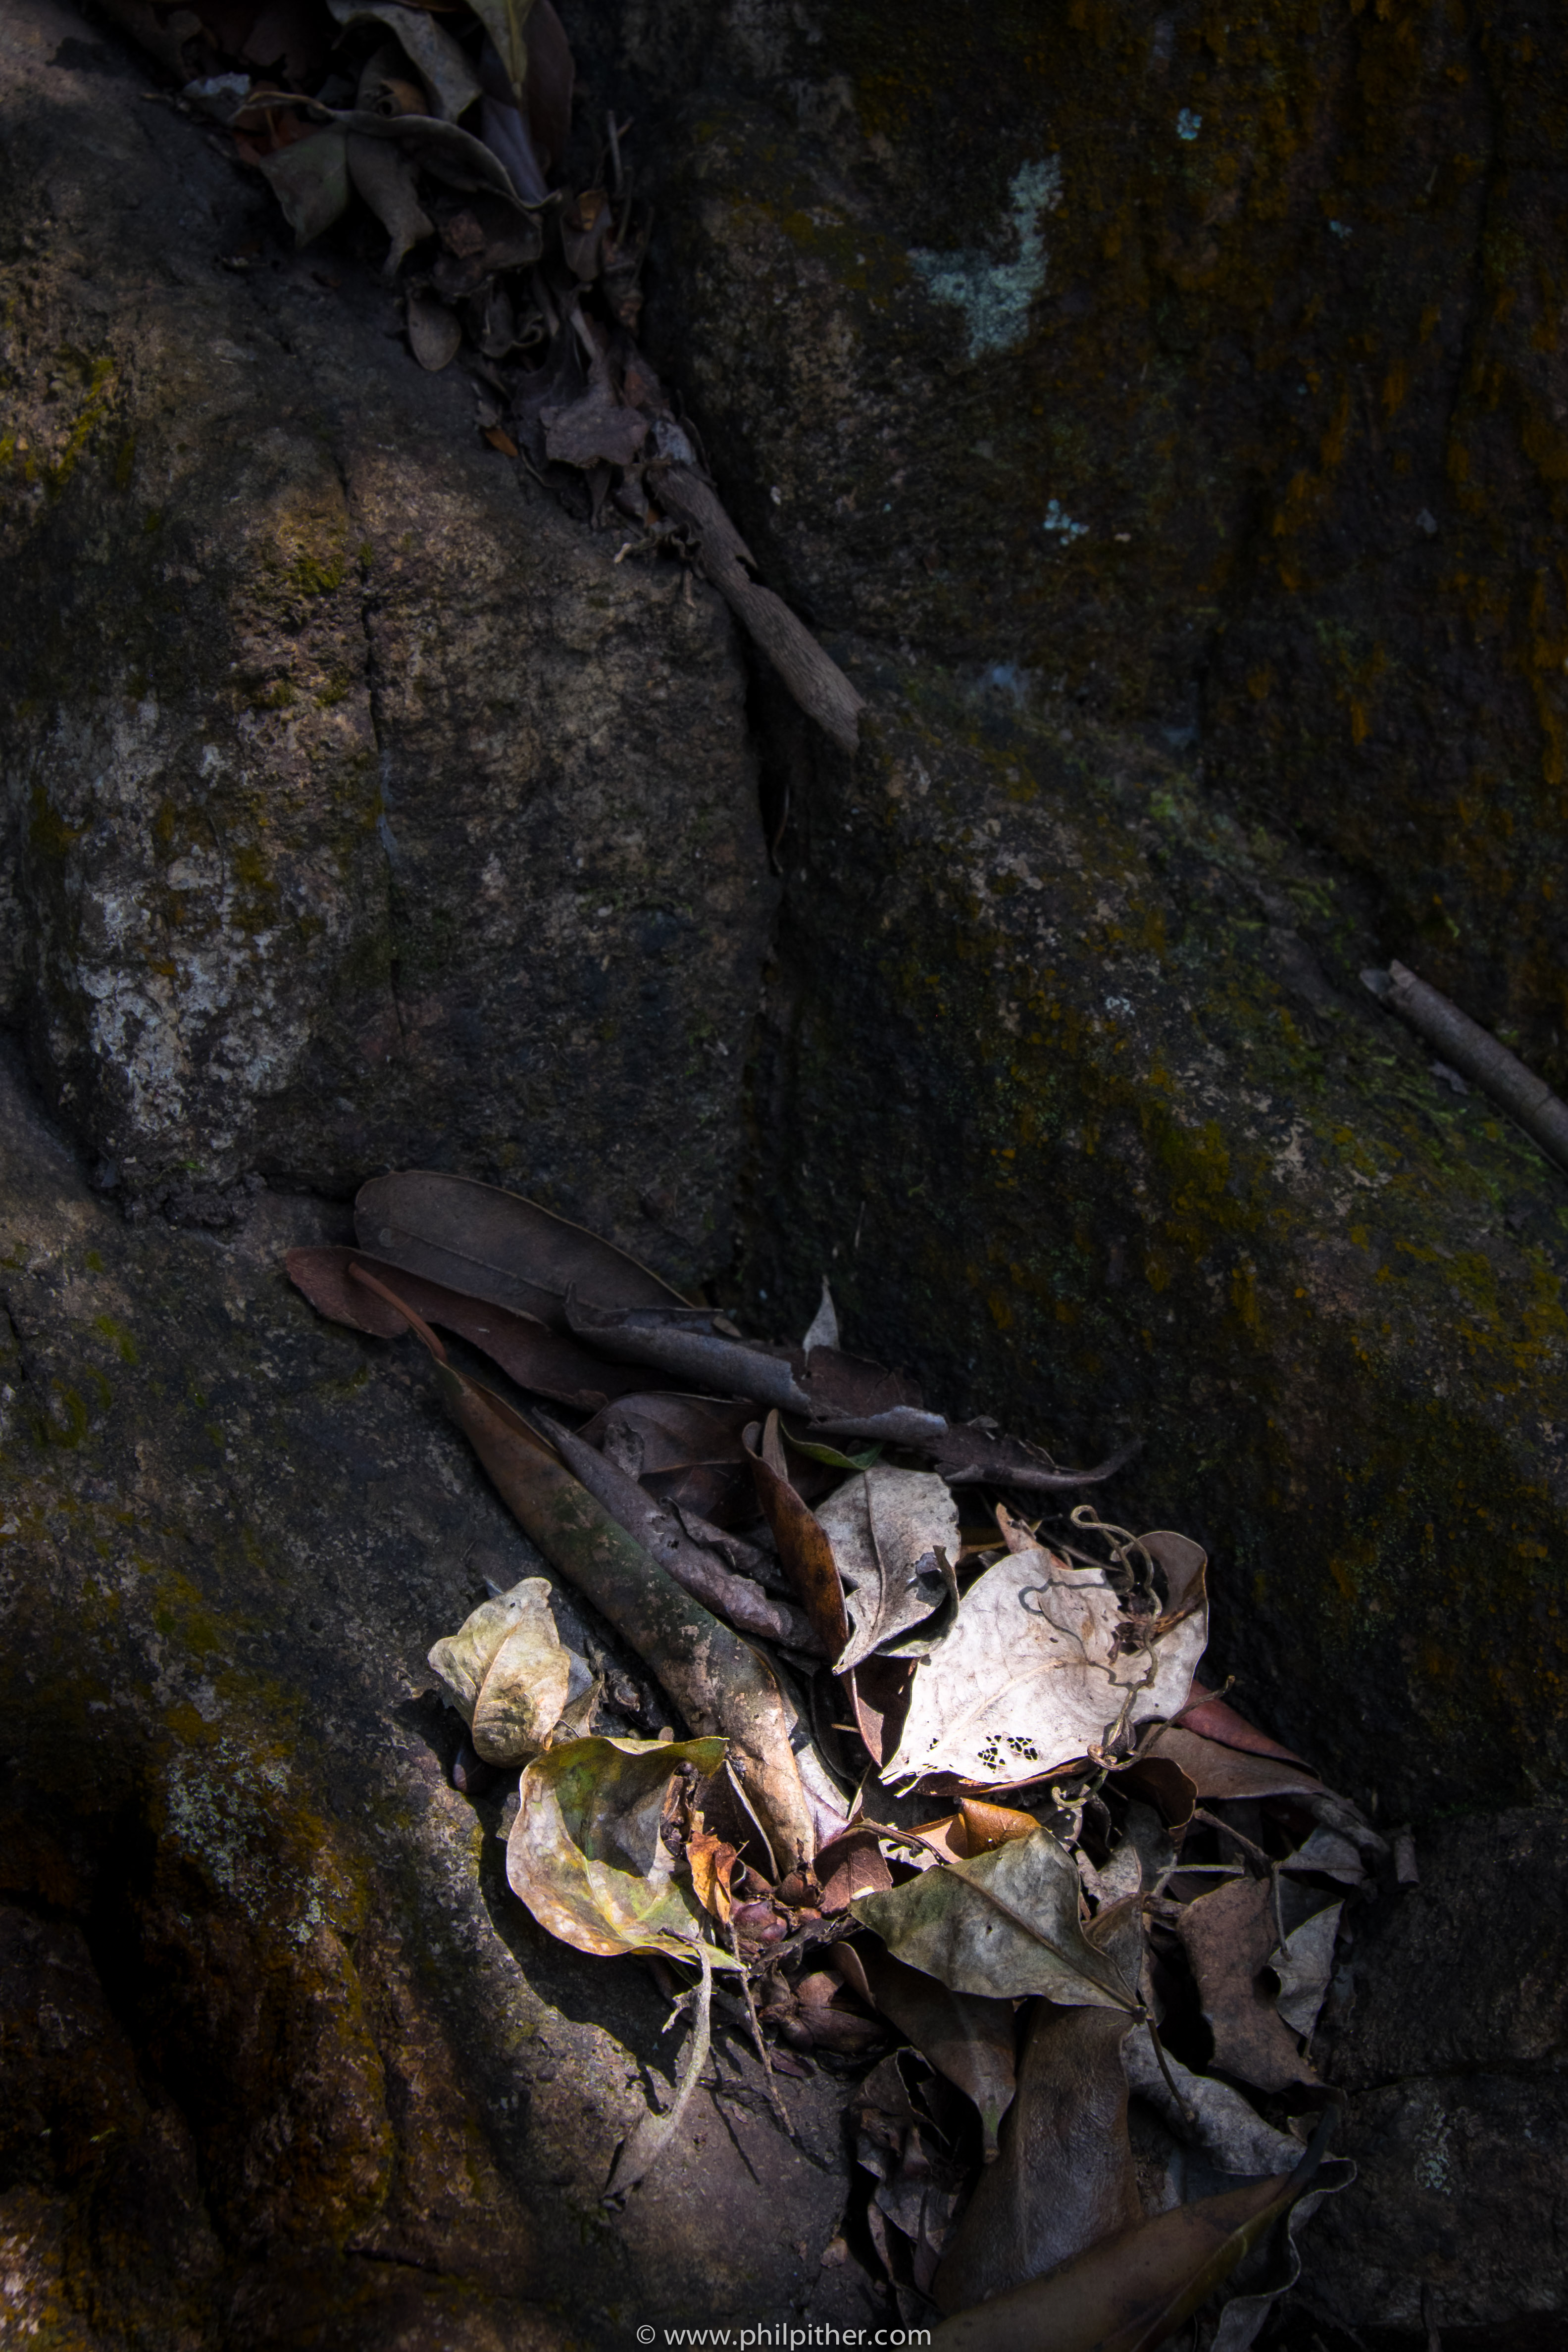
[289,1171,1382,2352]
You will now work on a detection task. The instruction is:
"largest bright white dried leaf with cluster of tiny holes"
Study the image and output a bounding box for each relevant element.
[882,1534,1229,1785]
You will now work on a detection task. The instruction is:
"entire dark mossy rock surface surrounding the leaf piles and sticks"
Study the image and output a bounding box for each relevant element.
[0,0,1568,2352]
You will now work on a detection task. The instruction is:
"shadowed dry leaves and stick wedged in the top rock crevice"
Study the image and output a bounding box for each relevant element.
[103,0,860,751]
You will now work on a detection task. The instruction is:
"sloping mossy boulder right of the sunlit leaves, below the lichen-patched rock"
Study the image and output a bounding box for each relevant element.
[743,654,1568,1818]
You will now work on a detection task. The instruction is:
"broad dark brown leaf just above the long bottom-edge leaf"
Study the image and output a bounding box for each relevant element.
[936,1901,1143,2312]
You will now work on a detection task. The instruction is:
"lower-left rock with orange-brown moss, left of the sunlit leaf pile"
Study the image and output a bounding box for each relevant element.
[0,1061,874,2352]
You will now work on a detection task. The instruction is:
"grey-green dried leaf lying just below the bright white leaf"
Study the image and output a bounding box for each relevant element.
[851,1830,1138,2013]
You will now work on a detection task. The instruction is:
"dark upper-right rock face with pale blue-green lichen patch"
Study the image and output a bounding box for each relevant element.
[611,0,1568,1087]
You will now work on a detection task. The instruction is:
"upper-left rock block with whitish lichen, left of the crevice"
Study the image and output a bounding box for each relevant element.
[0,7,771,1277]
